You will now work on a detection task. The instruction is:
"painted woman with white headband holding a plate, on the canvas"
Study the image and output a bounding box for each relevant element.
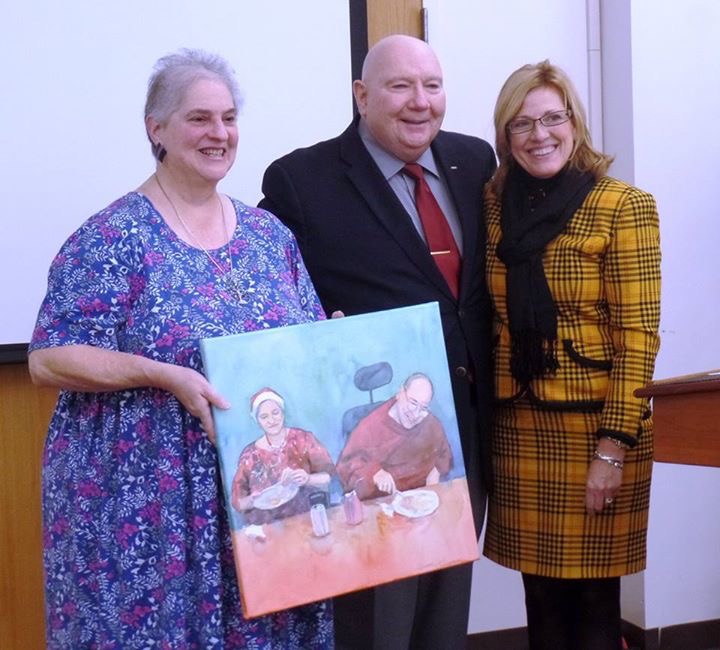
[232,388,335,524]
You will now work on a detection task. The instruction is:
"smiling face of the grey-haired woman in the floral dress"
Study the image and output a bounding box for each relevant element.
[147,79,238,184]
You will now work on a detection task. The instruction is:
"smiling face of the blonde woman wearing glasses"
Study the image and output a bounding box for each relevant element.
[508,86,575,178]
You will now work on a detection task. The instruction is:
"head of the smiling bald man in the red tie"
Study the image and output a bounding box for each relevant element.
[353,36,445,162]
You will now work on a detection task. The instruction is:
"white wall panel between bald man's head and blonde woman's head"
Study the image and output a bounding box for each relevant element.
[423,0,589,145]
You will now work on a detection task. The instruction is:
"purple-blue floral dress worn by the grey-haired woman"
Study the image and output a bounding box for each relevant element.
[30,192,333,650]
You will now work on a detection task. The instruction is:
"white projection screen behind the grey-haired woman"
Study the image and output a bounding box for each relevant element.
[0,0,352,344]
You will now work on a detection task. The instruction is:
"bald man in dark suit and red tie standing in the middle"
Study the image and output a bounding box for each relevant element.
[260,35,496,650]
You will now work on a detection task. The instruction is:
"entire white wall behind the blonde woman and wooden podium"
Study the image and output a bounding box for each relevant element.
[424,0,720,633]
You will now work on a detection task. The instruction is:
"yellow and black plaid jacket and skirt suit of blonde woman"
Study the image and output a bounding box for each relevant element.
[485,178,660,578]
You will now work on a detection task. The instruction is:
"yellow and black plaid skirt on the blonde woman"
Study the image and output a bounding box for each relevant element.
[484,400,652,578]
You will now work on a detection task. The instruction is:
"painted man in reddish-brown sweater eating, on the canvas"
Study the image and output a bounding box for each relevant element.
[337,373,453,499]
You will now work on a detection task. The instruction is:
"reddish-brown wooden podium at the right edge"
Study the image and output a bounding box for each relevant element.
[635,370,720,467]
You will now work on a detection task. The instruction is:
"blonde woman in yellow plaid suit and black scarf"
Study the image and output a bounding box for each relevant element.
[484,61,660,650]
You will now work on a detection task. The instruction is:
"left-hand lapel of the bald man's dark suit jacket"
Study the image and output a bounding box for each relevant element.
[340,123,452,298]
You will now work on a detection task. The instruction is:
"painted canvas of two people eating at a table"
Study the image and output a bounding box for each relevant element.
[201,303,478,617]
